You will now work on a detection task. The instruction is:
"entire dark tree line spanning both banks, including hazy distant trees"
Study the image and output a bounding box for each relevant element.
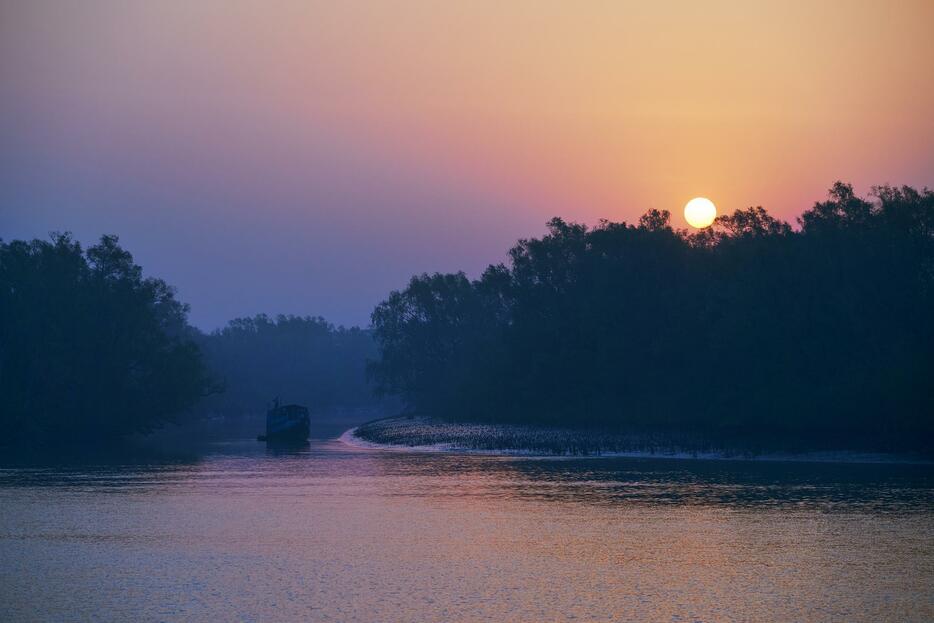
[0,183,934,445]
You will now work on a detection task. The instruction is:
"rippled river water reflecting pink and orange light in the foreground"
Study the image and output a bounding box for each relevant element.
[0,428,934,621]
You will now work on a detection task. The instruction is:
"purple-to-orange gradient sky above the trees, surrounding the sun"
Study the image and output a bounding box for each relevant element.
[0,0,934,330]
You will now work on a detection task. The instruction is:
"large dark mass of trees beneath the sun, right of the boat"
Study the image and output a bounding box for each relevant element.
[370,183,934,446]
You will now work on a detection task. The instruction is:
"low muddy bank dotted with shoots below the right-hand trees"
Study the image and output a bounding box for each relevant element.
[340,417,931,463]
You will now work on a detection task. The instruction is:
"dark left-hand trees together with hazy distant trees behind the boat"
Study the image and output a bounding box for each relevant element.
[0,234,376,445]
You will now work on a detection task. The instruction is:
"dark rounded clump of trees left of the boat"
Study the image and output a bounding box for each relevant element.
[0,234,210,442]
